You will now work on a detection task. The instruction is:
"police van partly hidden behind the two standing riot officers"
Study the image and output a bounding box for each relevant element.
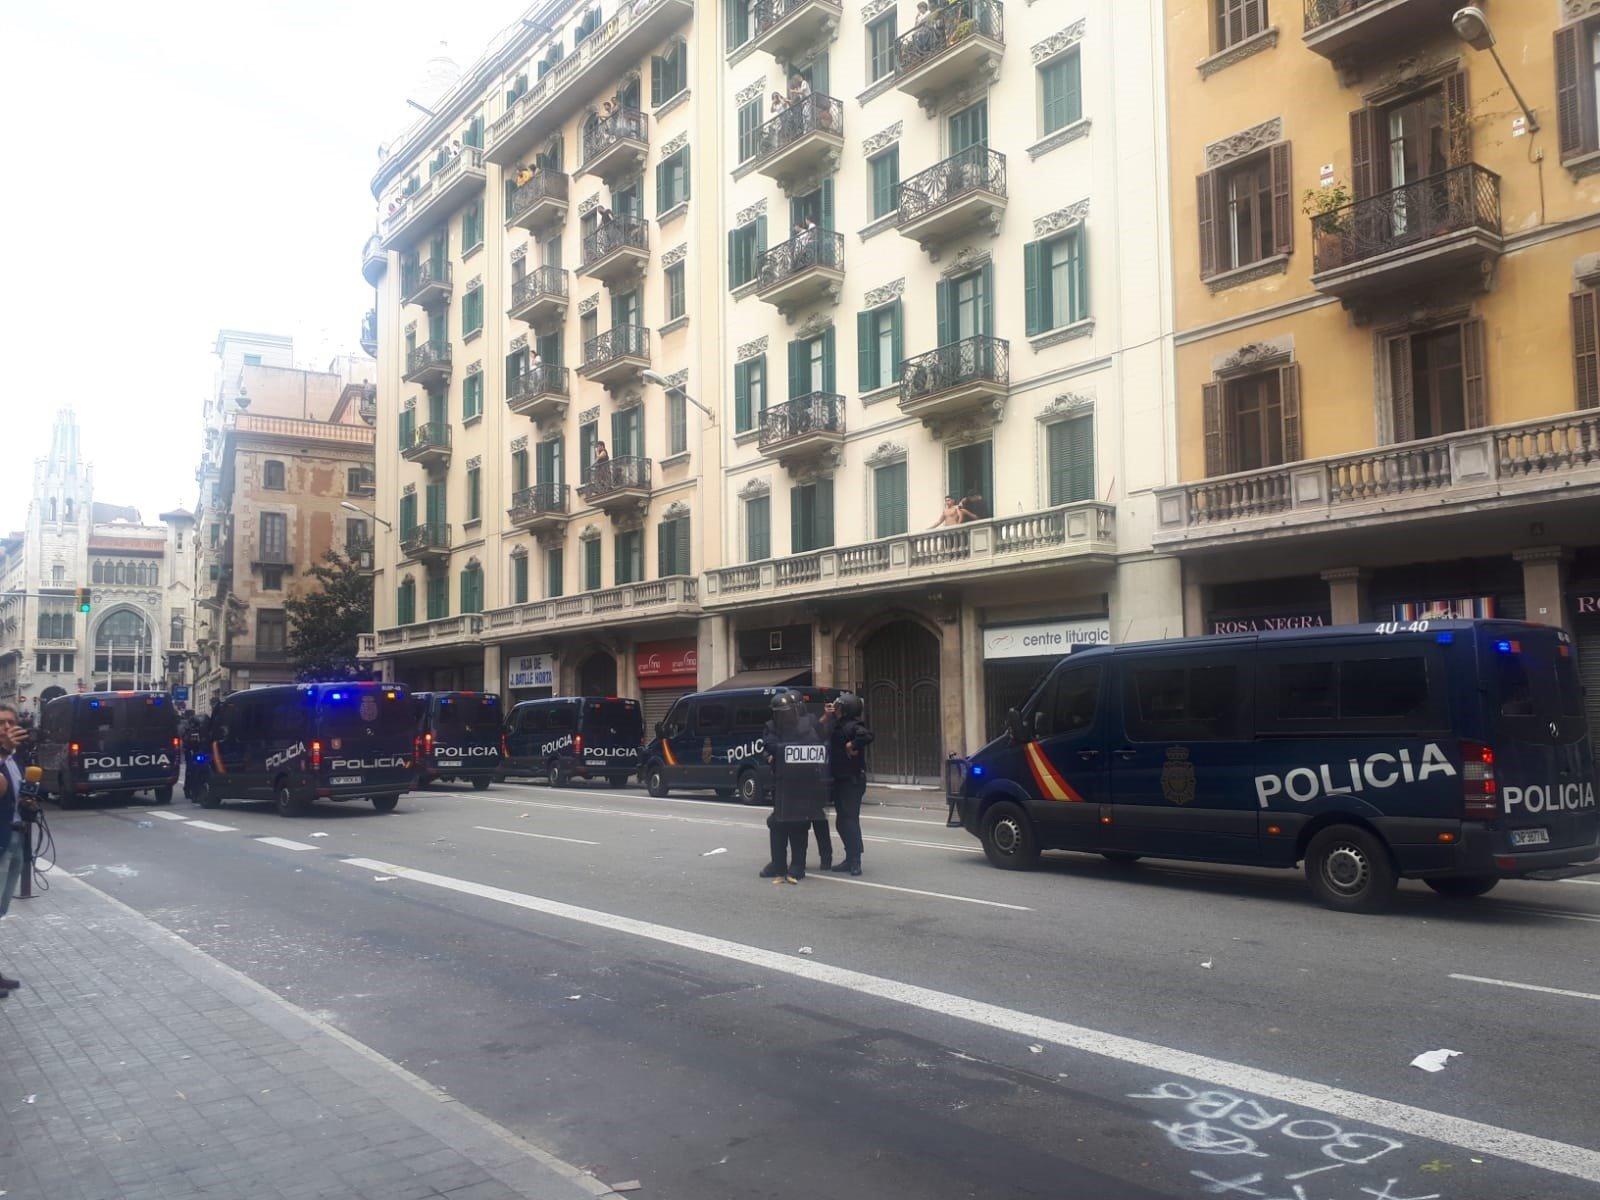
[642,688,838,805]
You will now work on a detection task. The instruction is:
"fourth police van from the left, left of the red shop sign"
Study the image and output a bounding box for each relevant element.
[506,696,645,787]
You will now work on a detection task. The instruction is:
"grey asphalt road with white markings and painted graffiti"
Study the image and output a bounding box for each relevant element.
[45,784,1600,1200]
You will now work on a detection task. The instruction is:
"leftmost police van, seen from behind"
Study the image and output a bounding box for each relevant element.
[35,691,182,805]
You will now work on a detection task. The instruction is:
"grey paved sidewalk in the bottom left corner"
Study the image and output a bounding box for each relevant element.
[0,874,614,1200]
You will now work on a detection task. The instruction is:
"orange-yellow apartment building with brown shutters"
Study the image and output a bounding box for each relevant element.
[1155,0,1600,732]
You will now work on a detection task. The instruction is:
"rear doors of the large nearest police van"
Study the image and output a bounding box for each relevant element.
[1477,626,1600,854]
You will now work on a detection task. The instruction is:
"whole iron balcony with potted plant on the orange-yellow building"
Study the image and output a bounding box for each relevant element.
[1310,163,1502,304]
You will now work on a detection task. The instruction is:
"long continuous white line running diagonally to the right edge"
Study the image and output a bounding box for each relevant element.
[342,858,1600,1182]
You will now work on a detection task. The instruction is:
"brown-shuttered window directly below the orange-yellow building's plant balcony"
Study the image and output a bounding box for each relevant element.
[1389,320,1488,442]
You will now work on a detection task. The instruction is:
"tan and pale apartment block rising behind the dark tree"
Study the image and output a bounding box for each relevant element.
[195,330,376,712]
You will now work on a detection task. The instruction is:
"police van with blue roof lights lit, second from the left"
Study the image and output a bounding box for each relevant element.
[195,683,418,816]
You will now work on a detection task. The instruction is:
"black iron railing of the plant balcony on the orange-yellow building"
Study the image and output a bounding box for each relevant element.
[1312,163,1501,274]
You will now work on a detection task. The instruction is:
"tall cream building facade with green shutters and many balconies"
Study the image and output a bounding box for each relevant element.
[363,0,1181,779]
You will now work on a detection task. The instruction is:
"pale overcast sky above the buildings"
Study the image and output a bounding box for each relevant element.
[0,0,512,531]
